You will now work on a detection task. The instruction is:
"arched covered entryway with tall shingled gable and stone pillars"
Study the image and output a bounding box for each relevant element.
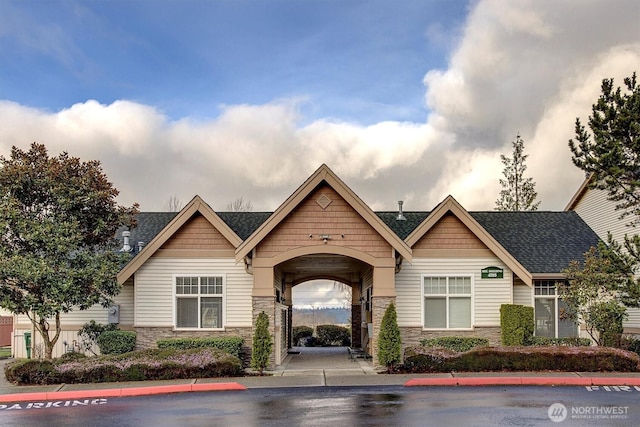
[236,165,411,365]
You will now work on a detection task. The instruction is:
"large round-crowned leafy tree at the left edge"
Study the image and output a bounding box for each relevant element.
[0,143,137,359]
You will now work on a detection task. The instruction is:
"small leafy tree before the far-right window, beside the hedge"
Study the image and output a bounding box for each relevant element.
[557,244,635,345]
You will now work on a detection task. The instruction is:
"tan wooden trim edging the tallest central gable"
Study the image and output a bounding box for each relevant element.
[236,164,412,262]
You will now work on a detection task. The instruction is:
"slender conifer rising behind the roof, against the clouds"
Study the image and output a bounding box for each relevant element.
[496,134,540,211]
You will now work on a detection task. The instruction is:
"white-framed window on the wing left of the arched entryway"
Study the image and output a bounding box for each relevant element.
[176,276,224,329]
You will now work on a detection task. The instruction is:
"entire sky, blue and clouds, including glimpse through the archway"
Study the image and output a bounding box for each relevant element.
[0,0,640,305]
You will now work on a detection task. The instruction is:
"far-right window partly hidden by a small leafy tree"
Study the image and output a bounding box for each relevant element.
[533,280,578,338]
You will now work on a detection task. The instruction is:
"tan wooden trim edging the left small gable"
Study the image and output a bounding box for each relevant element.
[117,196,242,284]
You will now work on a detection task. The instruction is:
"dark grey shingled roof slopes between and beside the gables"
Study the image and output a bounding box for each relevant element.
[119,211,599,274]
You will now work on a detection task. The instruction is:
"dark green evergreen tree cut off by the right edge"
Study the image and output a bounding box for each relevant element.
[569,72,640,224]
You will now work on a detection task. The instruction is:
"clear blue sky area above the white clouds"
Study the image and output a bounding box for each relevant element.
[0,0,467,124]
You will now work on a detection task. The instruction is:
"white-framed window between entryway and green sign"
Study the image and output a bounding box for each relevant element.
[422,276,471,329]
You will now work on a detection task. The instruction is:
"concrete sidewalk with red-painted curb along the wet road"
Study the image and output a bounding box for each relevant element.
[0,348,640,404]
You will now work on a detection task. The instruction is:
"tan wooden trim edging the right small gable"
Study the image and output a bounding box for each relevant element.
[405,196,533,286]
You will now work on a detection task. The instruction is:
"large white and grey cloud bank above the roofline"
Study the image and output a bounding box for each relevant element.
[0,0,640,214]
